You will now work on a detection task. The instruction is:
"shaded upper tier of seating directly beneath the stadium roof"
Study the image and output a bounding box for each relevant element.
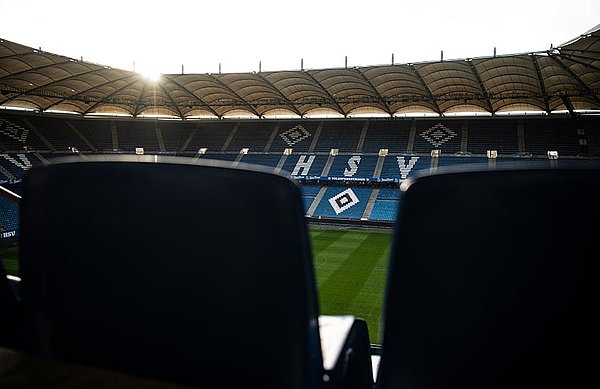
[0,111,600,157]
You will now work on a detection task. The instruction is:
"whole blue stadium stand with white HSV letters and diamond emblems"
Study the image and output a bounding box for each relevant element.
[0,111,600,230]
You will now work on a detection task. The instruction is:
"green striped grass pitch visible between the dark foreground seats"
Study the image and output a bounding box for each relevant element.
[0,228,391,343]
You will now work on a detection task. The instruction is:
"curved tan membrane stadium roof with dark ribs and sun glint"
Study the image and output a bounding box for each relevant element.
[0,25,600,119]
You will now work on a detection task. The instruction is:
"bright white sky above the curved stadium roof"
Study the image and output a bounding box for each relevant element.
[0,0,600,79]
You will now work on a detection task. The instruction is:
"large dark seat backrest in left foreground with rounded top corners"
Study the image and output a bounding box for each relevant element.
[20,156,322,388]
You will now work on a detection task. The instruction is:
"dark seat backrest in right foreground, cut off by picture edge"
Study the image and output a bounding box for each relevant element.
[378,169,600,389]
